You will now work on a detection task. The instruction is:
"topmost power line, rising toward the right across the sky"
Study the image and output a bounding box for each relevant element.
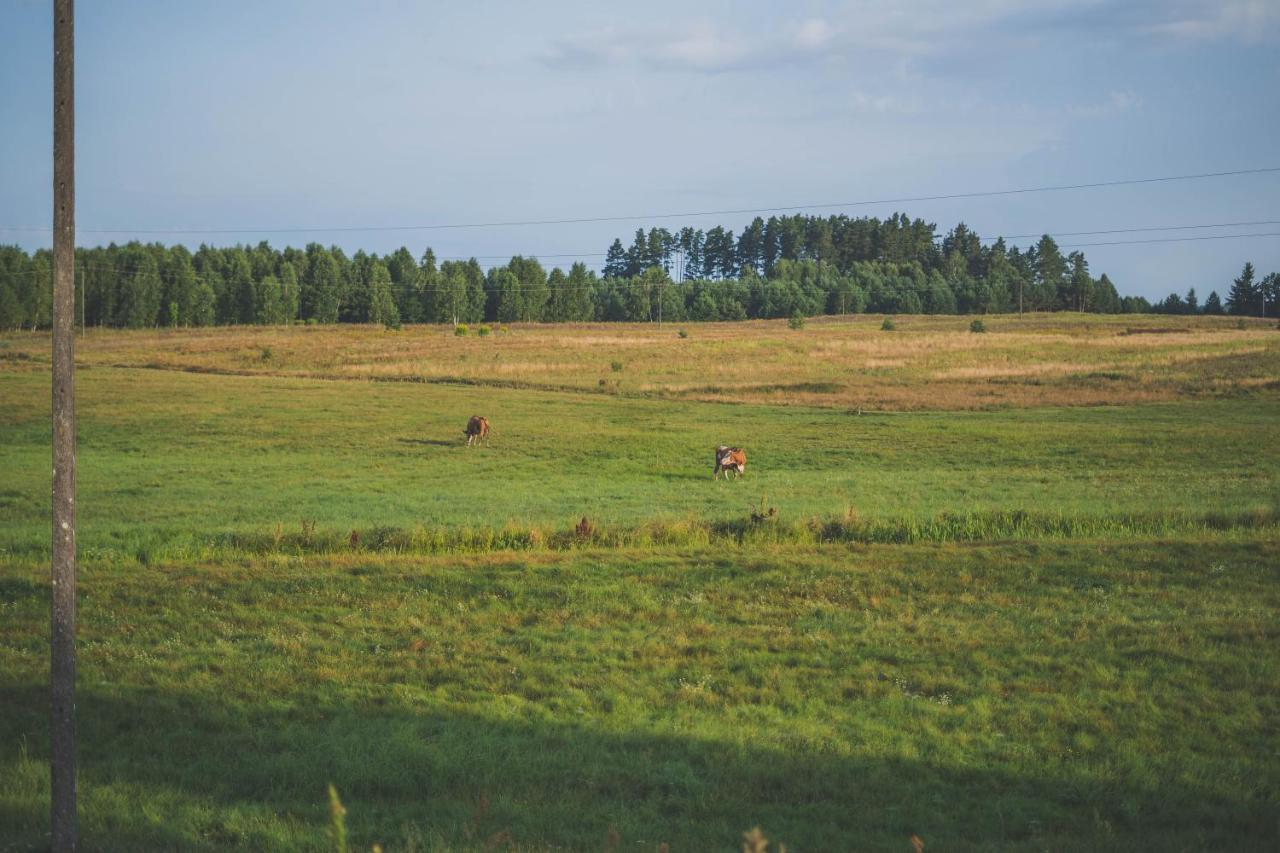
[0,167,1280,234]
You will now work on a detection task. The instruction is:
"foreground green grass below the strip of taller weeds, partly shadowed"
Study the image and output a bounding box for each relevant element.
[0,538,1280,850]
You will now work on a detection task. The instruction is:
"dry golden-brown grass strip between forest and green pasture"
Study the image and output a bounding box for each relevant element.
[0,314,1280,411]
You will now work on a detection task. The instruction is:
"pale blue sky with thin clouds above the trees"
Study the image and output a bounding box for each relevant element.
[0,0,1280,298]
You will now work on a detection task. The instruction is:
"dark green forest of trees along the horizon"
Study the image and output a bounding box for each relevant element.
[0,214,1280,329]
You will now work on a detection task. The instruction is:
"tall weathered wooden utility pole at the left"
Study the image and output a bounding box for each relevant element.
[49,0,76,853]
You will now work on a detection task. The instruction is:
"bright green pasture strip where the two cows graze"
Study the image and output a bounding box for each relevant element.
[0,369,1280,558]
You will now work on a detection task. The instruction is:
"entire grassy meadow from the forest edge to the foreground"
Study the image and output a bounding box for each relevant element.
[0,316,1280,852]
